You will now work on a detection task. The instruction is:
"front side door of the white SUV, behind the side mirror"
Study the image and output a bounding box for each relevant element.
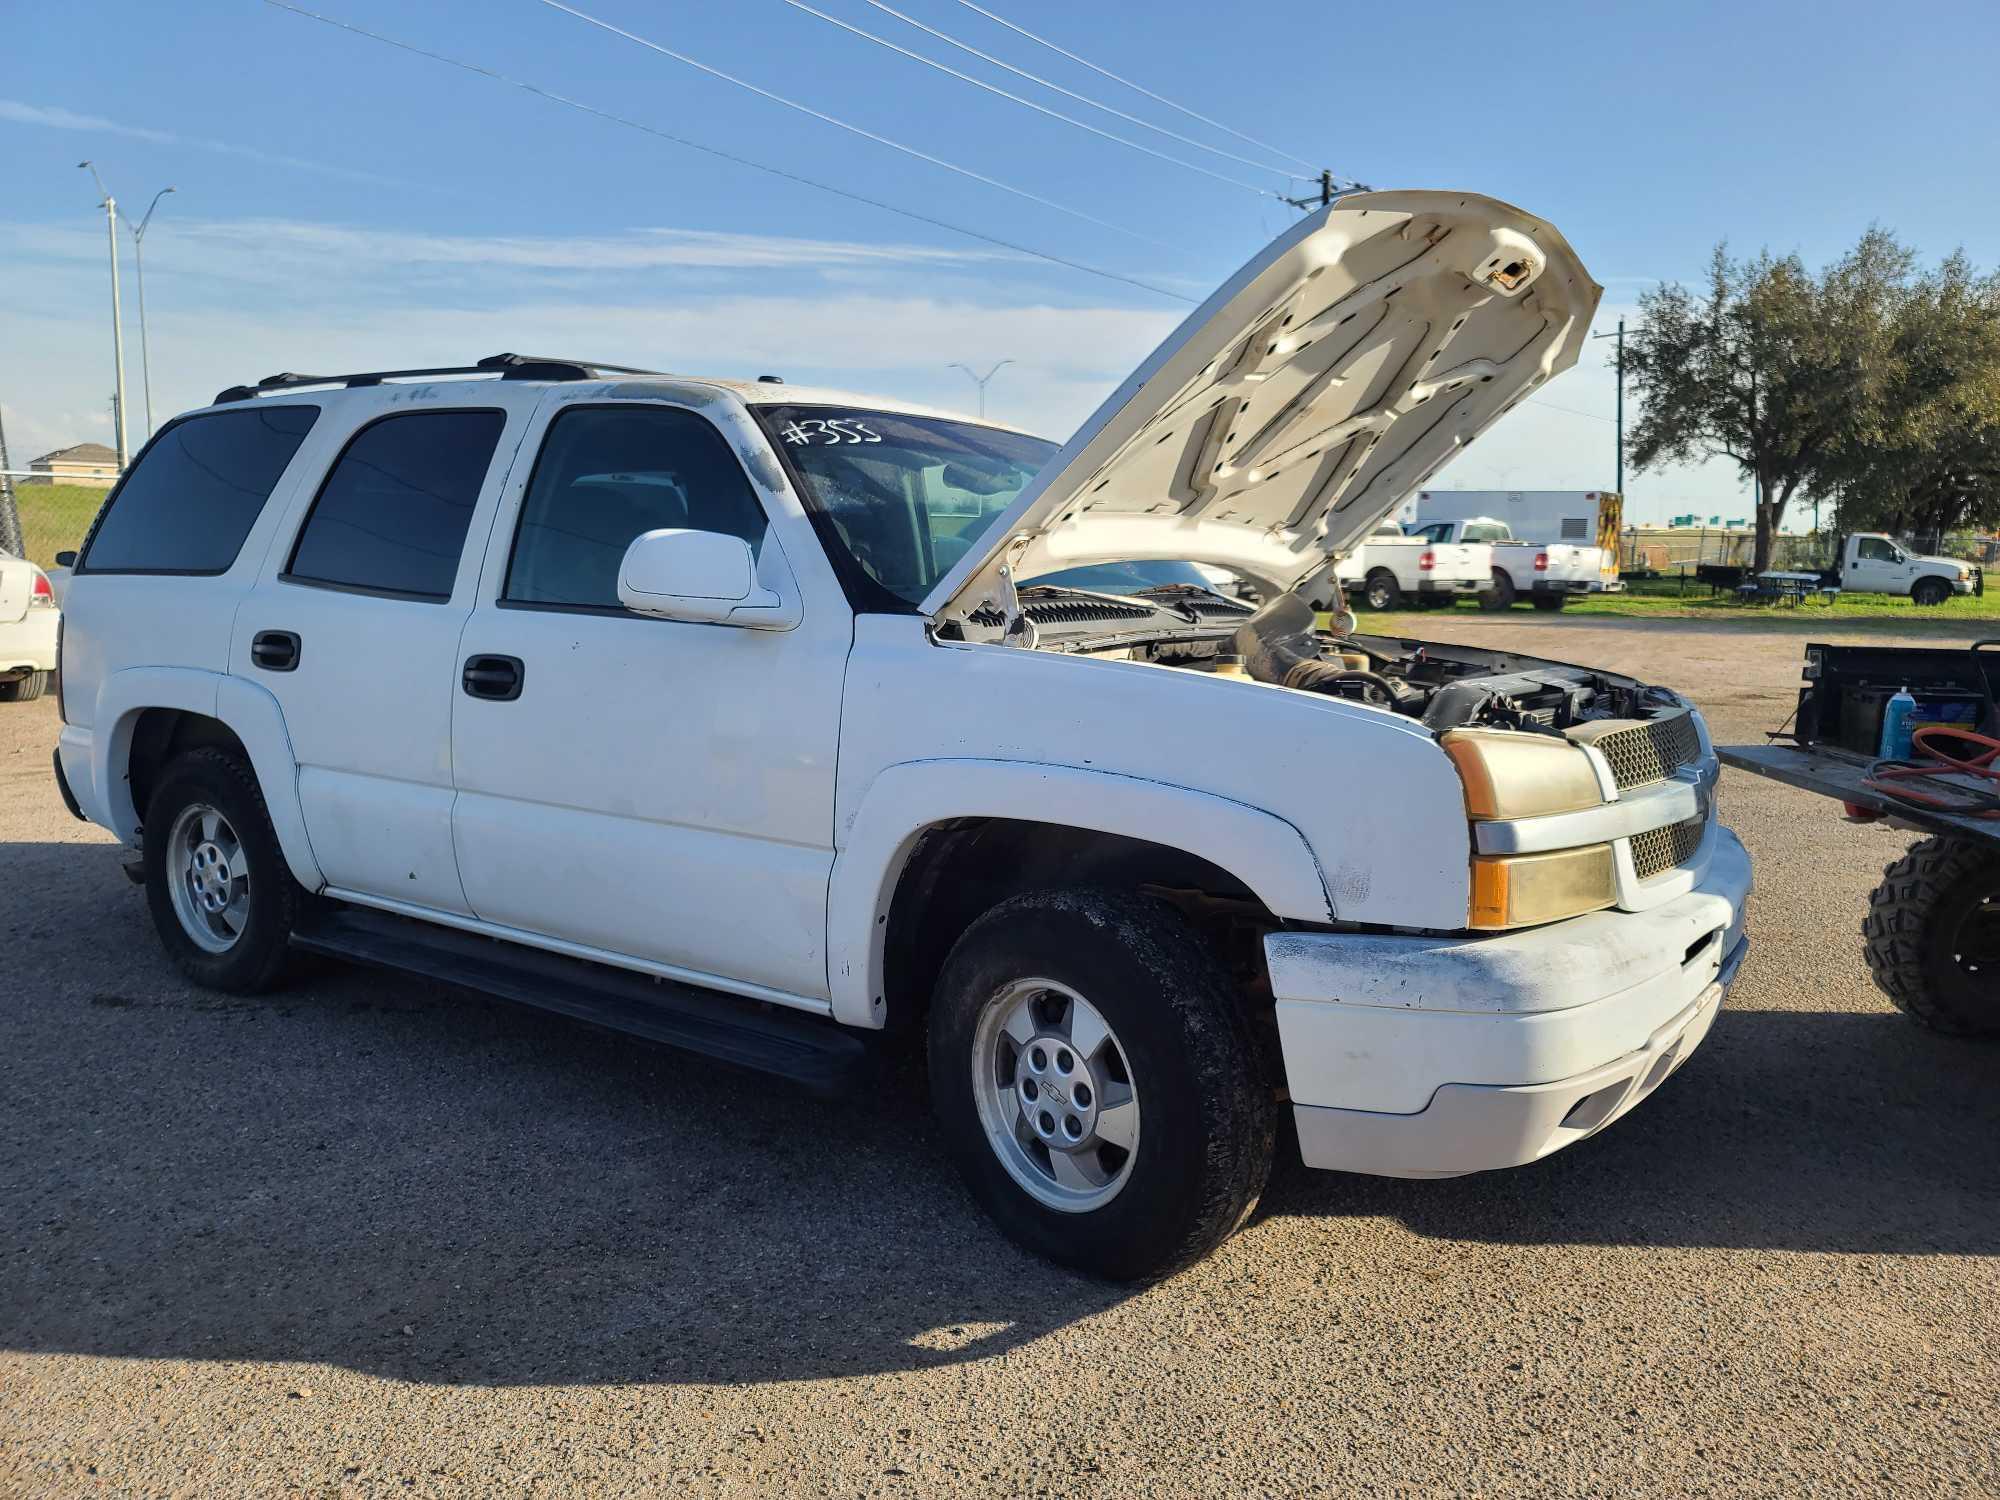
[452,398,852,1004]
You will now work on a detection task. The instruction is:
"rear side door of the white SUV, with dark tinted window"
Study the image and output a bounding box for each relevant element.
[230,394,540,916]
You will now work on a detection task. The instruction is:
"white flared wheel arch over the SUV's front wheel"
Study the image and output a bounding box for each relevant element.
[828,760,1334,1026]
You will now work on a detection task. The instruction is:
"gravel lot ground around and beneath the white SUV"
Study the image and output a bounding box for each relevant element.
[0,614,2000,1496]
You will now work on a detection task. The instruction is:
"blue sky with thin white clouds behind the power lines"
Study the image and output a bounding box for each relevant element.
[0,0,2000,518]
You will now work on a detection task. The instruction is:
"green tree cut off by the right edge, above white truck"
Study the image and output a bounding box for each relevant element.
[1816,254,2000,538]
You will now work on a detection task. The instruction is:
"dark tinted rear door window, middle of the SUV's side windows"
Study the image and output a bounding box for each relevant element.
[286,412,506,600]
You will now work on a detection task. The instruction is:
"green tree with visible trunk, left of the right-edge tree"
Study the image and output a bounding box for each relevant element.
[1626,228,1916,570]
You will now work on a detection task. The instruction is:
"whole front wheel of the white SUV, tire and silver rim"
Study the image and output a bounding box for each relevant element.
[930,886,1278,1282]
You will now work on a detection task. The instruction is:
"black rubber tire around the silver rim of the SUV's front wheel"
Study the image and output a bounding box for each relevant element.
[928,886,1278,1282]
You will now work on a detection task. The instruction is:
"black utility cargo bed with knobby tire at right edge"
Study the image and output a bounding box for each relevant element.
[1716,640,2000,1036]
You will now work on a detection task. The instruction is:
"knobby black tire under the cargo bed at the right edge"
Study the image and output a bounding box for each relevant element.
[1862,838,2000,1036]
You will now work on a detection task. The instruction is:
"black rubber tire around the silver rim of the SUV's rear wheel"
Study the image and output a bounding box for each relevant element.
[142,746,306,994]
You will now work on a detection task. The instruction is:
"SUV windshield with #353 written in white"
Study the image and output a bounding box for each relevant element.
[754,406,1056,608]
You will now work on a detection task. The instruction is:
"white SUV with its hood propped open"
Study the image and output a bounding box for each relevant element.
[56,192,1750,1278]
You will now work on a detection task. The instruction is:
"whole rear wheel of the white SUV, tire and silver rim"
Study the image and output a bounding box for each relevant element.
[144,746,306,994]
